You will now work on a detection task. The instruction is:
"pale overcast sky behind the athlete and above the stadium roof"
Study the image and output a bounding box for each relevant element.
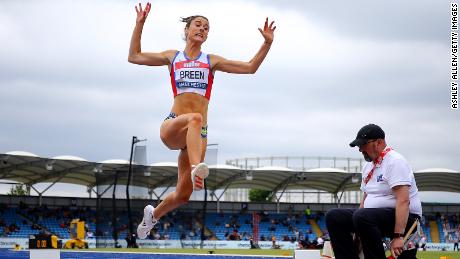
[0,0,460,200]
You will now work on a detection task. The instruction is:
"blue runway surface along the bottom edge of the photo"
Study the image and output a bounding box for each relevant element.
[0,249,292,259]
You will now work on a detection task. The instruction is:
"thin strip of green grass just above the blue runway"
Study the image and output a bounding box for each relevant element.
[80,248,460,259]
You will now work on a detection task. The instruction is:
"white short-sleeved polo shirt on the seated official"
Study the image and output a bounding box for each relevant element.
[361,150,422,216]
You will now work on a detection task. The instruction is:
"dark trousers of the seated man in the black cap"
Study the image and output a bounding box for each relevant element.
[326,208,418,259]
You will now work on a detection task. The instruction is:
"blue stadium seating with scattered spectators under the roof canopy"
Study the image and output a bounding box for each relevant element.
[0,204,458,247]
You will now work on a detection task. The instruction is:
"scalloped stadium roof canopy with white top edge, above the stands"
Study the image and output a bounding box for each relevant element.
[0,151,460,199]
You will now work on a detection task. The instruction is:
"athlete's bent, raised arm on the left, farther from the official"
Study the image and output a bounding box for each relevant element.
[128,3,176,66]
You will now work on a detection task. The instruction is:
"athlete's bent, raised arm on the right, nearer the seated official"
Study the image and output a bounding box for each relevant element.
[211,18,276,74]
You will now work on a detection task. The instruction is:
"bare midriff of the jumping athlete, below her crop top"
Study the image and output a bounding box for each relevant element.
[171,93,209,126]
